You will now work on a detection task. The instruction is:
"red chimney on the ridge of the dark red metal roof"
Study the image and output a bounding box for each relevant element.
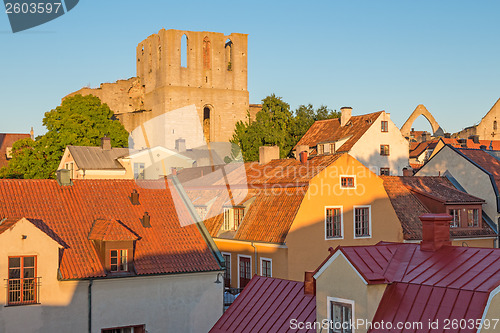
[420,214,451,251]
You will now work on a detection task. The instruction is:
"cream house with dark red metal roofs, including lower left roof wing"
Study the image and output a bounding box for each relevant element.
[210,214,500,333]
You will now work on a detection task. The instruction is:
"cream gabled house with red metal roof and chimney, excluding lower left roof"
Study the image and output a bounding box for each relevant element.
[313,214,500,333]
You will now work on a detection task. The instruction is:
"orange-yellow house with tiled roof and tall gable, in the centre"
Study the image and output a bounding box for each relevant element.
[186,147,403,288]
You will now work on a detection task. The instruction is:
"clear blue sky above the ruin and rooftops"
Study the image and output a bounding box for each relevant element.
[0,0,500,135]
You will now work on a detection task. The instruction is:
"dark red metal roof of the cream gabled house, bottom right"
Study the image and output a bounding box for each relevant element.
[316,243,500,332]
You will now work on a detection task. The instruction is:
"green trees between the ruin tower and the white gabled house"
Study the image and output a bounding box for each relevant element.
[231,94,340,161]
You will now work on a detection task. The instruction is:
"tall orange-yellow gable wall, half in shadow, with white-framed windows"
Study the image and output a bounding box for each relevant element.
[286,154,403,281]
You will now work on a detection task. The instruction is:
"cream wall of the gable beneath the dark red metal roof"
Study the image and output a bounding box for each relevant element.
[316,255,387,333]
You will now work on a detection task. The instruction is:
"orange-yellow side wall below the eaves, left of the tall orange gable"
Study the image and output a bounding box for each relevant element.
[214,238,288,288]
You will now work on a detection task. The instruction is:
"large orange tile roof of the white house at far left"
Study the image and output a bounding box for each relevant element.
[0,180,220,279]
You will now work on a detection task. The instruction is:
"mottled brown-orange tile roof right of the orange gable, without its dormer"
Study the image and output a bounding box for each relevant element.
[380,176,495,240]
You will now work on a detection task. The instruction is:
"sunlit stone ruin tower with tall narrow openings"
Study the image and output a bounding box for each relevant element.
[68,29,254,141]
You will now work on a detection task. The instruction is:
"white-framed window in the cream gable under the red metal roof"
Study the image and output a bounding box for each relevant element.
[327,297,354,333]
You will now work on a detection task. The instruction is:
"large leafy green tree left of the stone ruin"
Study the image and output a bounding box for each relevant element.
[0,95,128,179]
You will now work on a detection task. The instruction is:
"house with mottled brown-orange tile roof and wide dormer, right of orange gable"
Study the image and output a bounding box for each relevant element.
[381,176,497,248]
